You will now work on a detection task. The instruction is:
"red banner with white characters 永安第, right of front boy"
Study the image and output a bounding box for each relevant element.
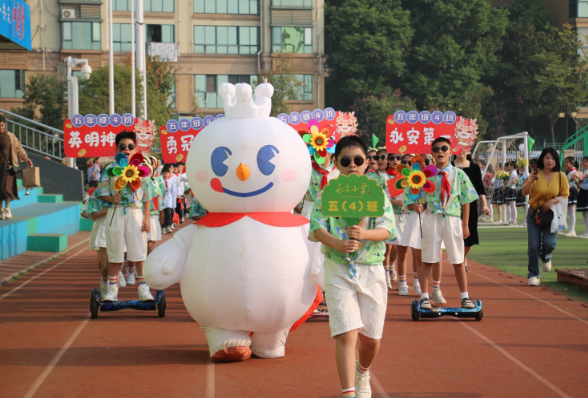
[386,111,458,154]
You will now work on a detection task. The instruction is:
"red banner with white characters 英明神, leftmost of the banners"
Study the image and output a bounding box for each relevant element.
[63,114,138,158]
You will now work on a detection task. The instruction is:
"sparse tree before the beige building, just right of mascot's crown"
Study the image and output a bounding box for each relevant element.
[257,52,304,117]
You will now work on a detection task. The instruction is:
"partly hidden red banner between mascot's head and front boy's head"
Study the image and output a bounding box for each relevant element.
[278,108,357,142]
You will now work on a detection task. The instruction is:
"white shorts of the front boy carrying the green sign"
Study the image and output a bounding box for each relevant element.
[324,258,388,340]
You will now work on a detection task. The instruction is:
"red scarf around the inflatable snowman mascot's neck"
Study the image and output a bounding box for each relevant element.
[196,212,310,228]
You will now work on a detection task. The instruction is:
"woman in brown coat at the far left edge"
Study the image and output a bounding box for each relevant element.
[0,115,33,220]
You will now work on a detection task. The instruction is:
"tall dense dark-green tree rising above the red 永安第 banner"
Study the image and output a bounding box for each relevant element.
[400,0,508,107]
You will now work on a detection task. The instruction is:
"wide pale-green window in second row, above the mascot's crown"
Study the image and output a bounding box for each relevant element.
[194,26,259,54]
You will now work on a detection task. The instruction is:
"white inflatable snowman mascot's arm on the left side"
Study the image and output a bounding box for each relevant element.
[143,225,198,290]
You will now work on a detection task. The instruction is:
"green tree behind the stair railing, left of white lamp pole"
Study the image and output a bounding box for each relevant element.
[12,74,67,130]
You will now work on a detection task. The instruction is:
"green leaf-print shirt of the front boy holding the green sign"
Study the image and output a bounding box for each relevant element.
[310,192,396,265]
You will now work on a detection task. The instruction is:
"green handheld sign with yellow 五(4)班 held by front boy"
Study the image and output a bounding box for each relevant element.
[321,174,386,226]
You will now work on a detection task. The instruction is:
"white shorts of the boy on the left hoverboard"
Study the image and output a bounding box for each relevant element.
[106,207,147,264]
